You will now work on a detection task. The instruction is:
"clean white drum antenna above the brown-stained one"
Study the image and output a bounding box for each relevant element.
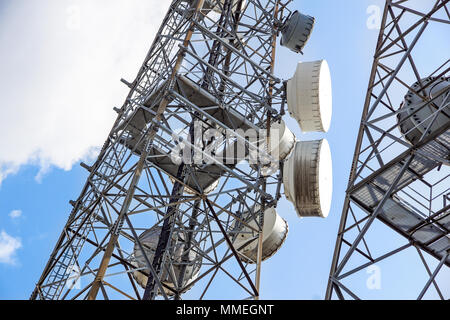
[287,60,333,132]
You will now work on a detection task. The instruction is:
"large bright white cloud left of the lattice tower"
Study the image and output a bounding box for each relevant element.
[0,0,170,183]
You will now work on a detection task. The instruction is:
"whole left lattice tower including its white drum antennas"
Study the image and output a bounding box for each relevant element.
[31,0,332,300]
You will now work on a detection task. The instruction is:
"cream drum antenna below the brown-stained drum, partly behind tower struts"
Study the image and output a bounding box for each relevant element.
[233,206,289,263]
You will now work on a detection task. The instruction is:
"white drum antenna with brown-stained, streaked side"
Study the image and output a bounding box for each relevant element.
[283,139,333,218]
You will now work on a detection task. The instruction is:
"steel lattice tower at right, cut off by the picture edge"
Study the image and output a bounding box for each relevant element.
[326,0,450,299]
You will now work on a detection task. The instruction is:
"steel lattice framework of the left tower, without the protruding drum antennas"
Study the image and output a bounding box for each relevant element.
[31,0,298,300]
